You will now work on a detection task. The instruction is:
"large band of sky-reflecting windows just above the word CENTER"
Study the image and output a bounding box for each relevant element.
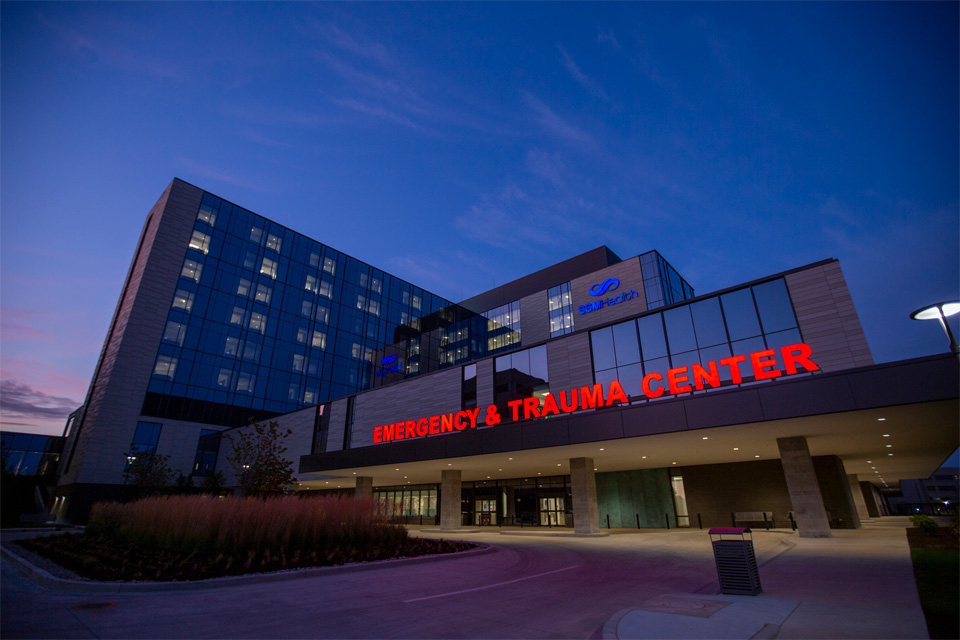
[590,278,802,400]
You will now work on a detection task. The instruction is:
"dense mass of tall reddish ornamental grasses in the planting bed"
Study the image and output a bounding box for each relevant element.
[87,496,408,555]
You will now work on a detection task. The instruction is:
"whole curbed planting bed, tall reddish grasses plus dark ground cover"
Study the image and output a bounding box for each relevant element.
[13,496,475,581]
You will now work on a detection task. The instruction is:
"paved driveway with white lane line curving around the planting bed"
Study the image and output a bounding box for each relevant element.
[2,532,748,639]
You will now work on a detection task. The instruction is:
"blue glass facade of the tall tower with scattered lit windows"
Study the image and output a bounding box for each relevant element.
[143,193,450,426]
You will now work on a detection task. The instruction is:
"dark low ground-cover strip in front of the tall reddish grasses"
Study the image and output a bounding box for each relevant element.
[13,533,475,582]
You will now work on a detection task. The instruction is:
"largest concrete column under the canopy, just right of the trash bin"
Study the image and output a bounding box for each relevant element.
[777,436,832,538]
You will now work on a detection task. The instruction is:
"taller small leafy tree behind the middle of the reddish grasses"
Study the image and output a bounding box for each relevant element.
[225,420,293,495]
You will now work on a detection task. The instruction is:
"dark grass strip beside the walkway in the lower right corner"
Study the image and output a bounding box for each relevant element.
[908,527,960,638]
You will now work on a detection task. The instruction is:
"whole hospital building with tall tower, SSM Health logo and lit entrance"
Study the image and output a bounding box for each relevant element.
[57,180,960,536]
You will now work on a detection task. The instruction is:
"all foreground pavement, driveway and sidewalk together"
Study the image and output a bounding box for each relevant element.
[0,520,926,640]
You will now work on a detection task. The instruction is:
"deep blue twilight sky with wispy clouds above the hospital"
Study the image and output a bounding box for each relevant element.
[0,2,960,440]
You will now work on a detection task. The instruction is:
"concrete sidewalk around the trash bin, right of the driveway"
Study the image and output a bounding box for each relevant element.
[603,518,927,638]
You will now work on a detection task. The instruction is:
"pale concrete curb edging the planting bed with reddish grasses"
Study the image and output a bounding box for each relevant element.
[0,541,497,593]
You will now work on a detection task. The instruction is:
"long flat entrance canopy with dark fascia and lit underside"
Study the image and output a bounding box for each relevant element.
[300,355,960,489]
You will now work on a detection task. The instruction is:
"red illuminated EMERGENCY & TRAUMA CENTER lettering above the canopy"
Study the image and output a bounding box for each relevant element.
[373,342,820,444]
